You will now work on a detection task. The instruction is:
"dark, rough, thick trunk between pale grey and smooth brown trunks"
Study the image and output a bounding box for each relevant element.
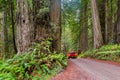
[33,0,51,42]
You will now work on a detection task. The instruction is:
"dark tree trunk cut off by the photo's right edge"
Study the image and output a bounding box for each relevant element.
[117,0,120,44]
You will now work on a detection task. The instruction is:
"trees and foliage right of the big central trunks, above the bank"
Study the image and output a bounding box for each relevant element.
[63,0,119,51]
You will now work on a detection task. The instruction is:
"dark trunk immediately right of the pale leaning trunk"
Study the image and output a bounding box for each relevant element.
[98,0,107,44]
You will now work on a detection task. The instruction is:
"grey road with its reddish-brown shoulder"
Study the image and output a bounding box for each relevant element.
[51,58,120,80]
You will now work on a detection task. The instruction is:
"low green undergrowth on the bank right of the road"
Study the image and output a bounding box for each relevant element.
[79,45,120,62]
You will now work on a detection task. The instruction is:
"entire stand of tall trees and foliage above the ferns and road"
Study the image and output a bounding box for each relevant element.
[0,0,120,55]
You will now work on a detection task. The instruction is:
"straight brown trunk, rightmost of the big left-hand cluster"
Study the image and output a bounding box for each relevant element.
[50,0,61,52]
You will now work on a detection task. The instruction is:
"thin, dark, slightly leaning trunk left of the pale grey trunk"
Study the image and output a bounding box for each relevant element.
[10,0,17,53]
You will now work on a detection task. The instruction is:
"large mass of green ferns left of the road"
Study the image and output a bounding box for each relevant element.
[0,40,67,80]
